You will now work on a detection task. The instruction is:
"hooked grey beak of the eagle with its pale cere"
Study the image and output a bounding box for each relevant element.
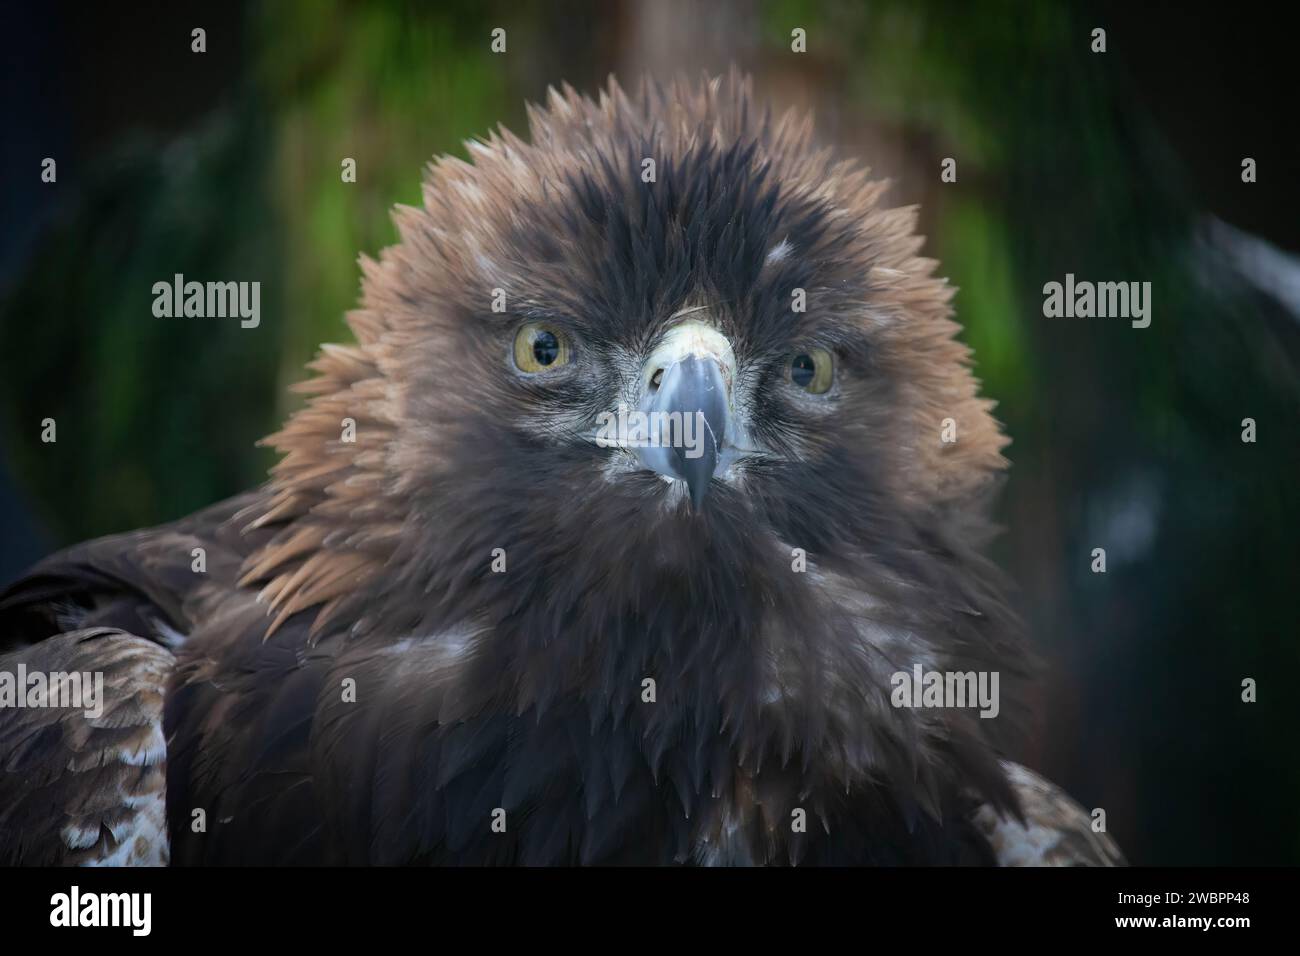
[636,321,736,511]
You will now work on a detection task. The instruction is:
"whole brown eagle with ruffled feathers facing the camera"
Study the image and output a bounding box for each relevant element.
[0,73,1119,865]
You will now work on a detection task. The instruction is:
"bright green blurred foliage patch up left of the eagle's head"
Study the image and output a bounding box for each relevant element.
[252,3,523,412]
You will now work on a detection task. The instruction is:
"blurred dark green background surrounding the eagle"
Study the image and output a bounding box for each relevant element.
[0,0,1300,864]
